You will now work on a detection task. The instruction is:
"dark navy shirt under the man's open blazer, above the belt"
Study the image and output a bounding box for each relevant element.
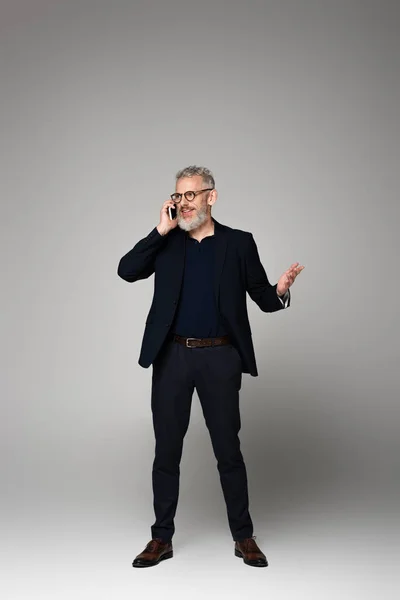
[171,234,227,338]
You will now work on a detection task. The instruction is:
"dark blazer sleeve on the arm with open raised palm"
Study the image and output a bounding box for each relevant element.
[246,233,290,312]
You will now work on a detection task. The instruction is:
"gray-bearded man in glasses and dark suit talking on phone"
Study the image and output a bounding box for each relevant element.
[118,166,304,567]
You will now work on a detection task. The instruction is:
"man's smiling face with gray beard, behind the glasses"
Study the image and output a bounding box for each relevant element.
[175,175,211,231]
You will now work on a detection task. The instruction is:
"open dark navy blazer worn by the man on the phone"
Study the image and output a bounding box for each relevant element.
[117,218,290,377]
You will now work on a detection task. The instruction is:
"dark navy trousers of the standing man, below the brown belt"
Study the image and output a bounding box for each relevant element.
[151,341,253,541]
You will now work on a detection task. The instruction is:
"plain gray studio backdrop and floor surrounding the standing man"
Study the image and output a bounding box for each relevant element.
[0,0,400,600]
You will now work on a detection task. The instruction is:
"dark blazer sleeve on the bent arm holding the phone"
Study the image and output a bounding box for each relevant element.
[117,227,167,283]
